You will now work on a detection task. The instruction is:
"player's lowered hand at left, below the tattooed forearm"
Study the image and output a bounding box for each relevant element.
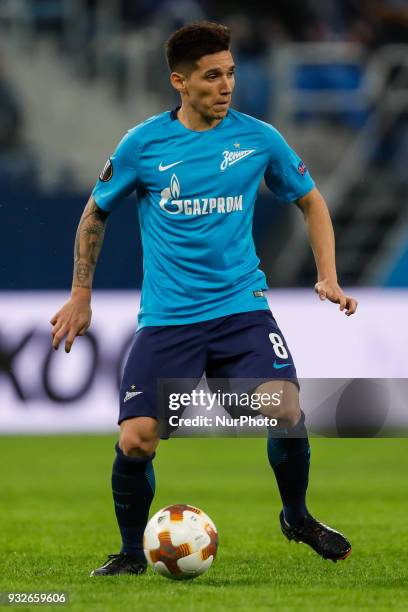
[50,297,92,353]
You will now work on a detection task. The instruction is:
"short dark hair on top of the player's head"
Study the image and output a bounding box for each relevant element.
[166,21,231,71]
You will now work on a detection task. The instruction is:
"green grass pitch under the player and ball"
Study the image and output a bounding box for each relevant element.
[0,435,408,612]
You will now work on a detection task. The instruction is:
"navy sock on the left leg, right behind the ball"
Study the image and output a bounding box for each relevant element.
[112,444,155,562]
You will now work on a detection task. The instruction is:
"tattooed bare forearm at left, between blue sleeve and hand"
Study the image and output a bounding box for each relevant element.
[73,198,109,289]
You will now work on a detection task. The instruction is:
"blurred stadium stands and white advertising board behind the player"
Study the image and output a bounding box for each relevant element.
[0,0,408,433]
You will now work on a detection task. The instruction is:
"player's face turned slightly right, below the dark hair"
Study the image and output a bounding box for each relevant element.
[183,51,235,121]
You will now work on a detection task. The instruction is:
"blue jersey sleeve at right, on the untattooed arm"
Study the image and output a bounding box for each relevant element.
[264,126,315,202]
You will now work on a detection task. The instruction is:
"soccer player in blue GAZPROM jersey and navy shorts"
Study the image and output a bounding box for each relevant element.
[51,22,357,576]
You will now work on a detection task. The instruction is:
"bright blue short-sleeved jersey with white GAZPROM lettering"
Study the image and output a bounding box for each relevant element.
[92,110,314,328]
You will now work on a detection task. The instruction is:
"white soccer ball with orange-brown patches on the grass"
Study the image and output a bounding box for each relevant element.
[143,504,218,580]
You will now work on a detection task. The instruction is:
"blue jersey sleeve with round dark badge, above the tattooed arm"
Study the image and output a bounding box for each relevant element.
[92,132,140,211]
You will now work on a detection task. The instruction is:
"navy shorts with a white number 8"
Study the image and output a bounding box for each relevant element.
[119,310,298,423]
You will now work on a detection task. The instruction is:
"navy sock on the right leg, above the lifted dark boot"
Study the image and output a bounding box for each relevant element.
[267,412,310,525]
